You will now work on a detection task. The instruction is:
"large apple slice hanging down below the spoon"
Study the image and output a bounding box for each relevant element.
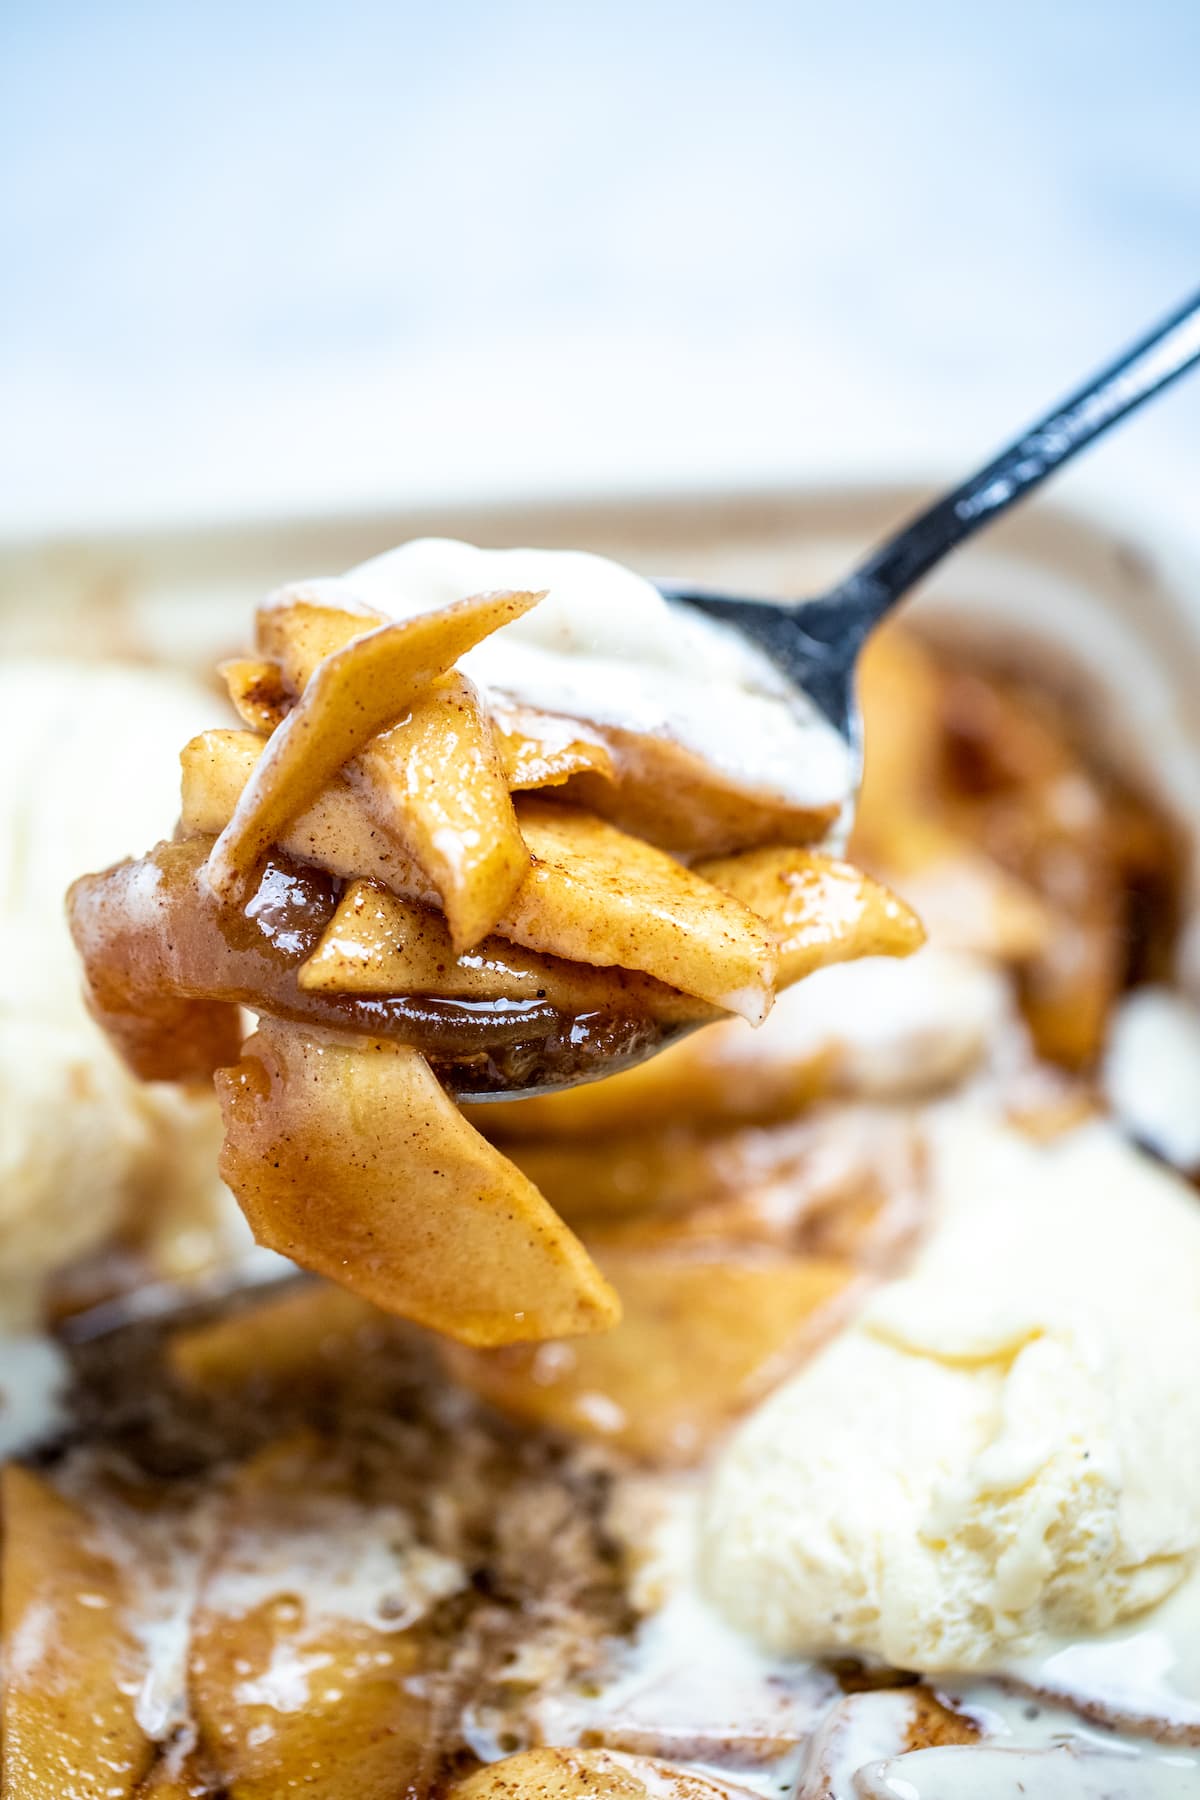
[216,1019,619,1345]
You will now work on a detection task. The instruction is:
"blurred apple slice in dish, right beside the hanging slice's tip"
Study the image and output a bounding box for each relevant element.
[444,1246,855,1463]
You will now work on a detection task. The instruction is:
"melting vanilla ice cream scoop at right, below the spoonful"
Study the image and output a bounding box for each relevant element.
[702,1107,1200,1672]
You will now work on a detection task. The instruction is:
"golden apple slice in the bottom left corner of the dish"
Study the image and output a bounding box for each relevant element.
[0,1463,153,1800]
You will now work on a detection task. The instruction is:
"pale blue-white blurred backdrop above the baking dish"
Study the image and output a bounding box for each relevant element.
[0,0,1200,540]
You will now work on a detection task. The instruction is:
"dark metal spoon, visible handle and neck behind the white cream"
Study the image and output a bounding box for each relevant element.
[657,293,1200,749]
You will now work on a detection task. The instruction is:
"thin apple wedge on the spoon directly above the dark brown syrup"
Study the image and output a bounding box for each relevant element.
[299,882,720,1024]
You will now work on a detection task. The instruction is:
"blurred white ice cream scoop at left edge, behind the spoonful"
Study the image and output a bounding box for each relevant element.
[0,659,237,1321]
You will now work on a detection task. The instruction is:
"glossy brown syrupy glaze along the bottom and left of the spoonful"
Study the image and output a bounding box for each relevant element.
[70,837,666,1096]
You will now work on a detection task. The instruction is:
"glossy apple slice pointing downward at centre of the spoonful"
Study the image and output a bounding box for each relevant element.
[347,673,529,952]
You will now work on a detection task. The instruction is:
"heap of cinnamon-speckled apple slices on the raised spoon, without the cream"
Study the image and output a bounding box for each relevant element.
[70,589,921,1345]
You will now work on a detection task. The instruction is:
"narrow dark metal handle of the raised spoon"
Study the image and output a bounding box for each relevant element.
[842,293,1200,619]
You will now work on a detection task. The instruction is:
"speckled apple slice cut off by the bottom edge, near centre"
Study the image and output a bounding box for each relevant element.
[450,1750,752,1800]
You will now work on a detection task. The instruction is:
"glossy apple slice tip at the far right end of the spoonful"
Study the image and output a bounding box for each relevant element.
[696,850,925,988]
